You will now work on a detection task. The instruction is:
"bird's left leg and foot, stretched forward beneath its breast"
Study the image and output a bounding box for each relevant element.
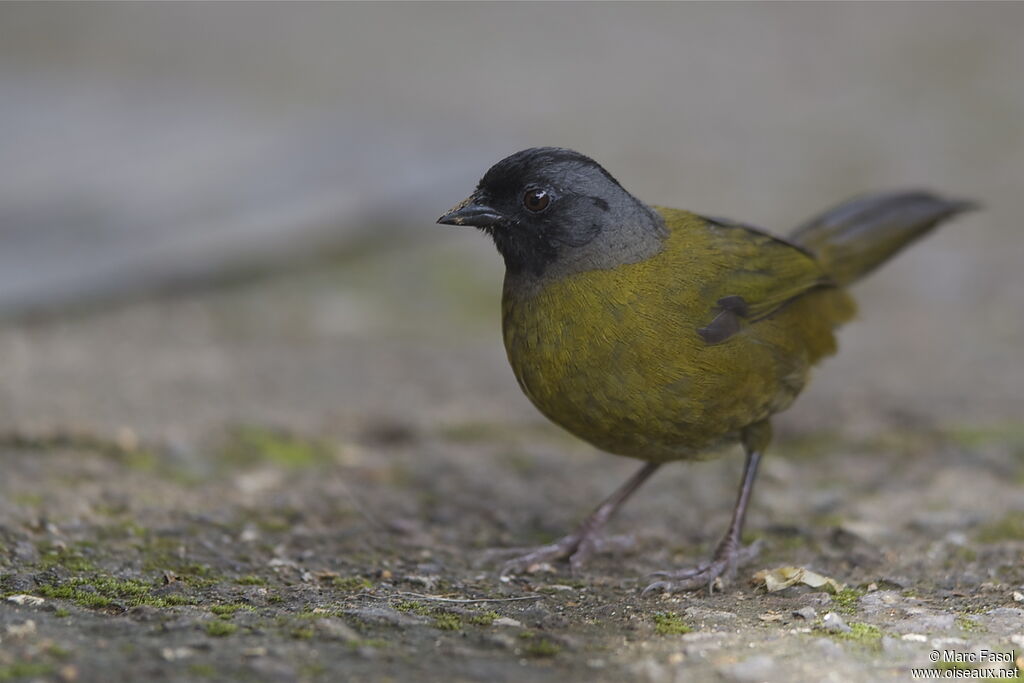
[501,463,660,577]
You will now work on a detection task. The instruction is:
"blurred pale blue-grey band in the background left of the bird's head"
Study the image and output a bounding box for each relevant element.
[0,72,481,315]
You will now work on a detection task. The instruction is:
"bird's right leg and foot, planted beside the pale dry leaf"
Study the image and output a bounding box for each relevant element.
[643,449,761,595]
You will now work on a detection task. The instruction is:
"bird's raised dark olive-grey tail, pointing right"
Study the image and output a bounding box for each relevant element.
[790,191,978,285]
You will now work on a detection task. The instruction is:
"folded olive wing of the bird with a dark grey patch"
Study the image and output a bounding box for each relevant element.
[697,217,835,344]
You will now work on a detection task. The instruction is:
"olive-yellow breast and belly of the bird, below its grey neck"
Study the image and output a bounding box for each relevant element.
[503,219,853,462]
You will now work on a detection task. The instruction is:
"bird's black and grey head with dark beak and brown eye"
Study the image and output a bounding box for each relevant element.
[437,147,659,275]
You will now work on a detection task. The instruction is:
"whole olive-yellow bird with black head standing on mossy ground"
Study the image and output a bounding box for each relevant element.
[437,147,977,593]
